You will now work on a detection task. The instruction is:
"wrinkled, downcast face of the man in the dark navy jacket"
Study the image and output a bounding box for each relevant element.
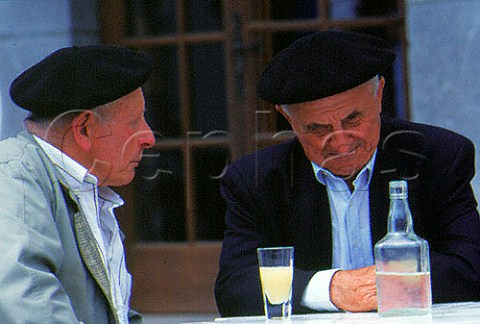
[277,78,384,180]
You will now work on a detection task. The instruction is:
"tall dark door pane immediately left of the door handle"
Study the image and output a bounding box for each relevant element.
[189,44,227,134]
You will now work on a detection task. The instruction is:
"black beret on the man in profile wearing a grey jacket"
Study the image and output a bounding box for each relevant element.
[10,45,153,117]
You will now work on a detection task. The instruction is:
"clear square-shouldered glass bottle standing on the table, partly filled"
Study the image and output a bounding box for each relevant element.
[374,181,432,316]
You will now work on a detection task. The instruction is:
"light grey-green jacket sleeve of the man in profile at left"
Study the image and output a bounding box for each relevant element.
[0,159,78,323]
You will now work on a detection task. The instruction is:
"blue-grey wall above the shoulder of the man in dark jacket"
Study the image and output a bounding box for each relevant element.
[406,0,480,201]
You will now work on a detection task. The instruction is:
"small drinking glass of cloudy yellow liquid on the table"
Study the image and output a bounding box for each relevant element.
[257,246,293,320]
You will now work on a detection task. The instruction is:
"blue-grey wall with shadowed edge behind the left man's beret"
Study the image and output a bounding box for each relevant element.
[0,0,99,139]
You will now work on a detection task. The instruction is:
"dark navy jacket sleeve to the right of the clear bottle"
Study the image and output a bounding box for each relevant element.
[429,136,480,303]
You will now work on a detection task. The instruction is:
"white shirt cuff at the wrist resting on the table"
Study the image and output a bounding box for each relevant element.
[301,269,340,312]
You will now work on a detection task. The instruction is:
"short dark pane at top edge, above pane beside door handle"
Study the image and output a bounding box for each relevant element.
[185,0,222,32]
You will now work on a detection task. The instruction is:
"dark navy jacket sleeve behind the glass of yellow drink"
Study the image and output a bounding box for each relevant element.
[215,165,314,316]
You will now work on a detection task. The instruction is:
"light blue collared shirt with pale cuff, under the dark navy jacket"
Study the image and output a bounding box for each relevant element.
[302,151,377,311]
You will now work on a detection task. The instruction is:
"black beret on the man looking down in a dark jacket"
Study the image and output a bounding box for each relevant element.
[257,30,395,104]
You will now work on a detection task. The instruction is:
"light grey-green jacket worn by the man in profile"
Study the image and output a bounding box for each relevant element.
[0,132,142,324]
